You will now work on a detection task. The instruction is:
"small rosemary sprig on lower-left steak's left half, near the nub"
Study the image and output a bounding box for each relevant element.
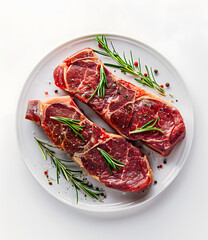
[50,117,85,142]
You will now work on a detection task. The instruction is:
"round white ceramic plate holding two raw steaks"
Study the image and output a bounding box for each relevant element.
[17,34,194,212]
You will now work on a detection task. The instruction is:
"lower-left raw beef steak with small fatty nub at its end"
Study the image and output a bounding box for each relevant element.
[26,96,153,192]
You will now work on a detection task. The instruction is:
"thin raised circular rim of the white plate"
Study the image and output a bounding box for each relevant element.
[15,33,195,213]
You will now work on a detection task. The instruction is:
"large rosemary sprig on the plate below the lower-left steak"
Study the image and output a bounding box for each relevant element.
[35,138,103,203]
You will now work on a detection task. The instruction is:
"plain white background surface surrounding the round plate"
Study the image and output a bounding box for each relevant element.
[0,0,208,240]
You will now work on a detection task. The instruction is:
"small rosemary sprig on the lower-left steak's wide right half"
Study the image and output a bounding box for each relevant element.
[97,148,126,175]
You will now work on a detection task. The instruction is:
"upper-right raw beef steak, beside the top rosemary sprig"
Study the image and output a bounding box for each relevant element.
[54,48,186,156]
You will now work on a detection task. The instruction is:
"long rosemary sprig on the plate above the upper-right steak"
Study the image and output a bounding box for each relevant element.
[93,35,166,96]
